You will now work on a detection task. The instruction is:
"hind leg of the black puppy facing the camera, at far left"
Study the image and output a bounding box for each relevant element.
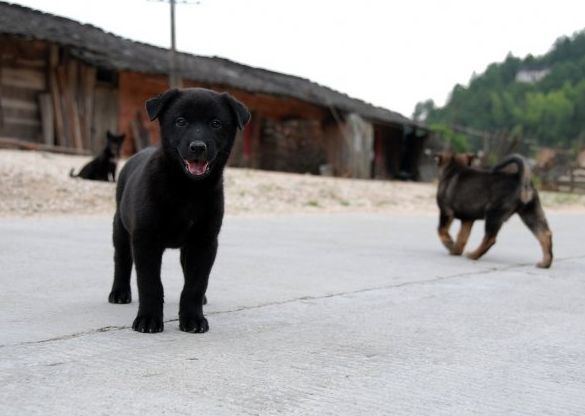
[108,213,132,303]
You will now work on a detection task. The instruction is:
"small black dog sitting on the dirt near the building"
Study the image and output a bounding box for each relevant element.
[69,130,126,182]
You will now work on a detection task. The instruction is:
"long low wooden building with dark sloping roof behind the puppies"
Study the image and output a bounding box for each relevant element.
[0,2,427,179]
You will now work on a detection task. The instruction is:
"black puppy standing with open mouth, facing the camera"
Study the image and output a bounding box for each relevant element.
[109,88,250,332]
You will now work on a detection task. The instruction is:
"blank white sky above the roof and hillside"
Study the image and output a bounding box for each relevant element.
[6,0,585,116]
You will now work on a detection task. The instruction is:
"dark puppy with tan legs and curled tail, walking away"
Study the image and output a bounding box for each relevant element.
[435,153,553,268]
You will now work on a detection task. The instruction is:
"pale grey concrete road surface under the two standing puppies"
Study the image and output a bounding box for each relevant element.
[0,215,585,416]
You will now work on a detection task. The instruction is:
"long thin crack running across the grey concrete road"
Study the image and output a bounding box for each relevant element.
[0,256,585,348]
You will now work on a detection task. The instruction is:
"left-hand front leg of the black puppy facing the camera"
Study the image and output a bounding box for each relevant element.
[132,238,164,333]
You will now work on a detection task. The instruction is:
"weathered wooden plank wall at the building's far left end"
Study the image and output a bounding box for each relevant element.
[0,36,96,150]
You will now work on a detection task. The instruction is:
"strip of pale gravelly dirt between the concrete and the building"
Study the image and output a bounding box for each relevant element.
[0,150,585,217]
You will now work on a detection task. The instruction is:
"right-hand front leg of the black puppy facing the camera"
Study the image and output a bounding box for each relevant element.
[179,237,217,333]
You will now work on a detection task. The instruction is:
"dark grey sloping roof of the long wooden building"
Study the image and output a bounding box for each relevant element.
[0,2,415,125]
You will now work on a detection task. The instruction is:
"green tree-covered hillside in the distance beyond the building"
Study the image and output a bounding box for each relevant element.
[413,30,585,153]
